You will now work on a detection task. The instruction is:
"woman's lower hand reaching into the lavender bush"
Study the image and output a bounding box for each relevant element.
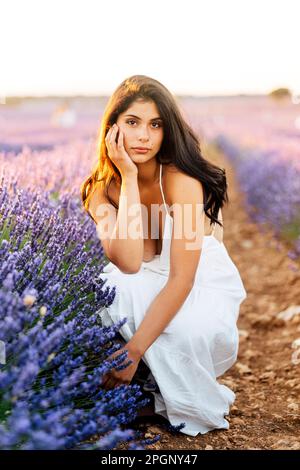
[101,345,141,390]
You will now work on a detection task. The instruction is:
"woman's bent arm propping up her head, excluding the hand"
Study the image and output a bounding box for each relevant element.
[89,172,144,274]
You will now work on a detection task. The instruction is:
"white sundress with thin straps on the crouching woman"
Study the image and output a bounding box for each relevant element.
[99,165,247,436]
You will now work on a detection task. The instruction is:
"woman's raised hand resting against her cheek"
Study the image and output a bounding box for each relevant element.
[105,124,138,177]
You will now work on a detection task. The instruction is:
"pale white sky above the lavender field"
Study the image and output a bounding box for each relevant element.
[0,0,300,99]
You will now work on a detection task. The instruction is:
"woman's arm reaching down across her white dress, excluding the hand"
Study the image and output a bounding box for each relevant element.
[125,172,204,357]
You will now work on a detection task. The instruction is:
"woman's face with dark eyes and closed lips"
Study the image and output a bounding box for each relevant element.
[117,101,163,163]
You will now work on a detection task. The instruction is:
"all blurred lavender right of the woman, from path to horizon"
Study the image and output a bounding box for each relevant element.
[184,97,300,264]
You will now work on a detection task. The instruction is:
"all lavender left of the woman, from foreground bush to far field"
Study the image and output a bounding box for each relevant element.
[0,96,172,449]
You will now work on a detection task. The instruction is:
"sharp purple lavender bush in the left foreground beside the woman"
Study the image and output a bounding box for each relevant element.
[0,178,157,449]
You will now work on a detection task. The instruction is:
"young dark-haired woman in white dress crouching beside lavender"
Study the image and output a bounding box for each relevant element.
[81,75,247,436]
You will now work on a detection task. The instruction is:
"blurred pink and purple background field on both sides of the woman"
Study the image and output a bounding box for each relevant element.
[0,90,300,259]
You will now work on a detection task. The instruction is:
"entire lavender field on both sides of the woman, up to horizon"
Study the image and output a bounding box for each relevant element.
[0,97,300,449]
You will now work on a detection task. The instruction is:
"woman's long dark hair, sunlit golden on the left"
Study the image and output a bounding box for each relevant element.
[81,75,228,227]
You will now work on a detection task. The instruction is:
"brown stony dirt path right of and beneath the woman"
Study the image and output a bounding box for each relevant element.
[131,144,300,450]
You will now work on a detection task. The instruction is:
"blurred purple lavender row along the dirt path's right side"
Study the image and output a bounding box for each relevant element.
[213,135,300,259]
